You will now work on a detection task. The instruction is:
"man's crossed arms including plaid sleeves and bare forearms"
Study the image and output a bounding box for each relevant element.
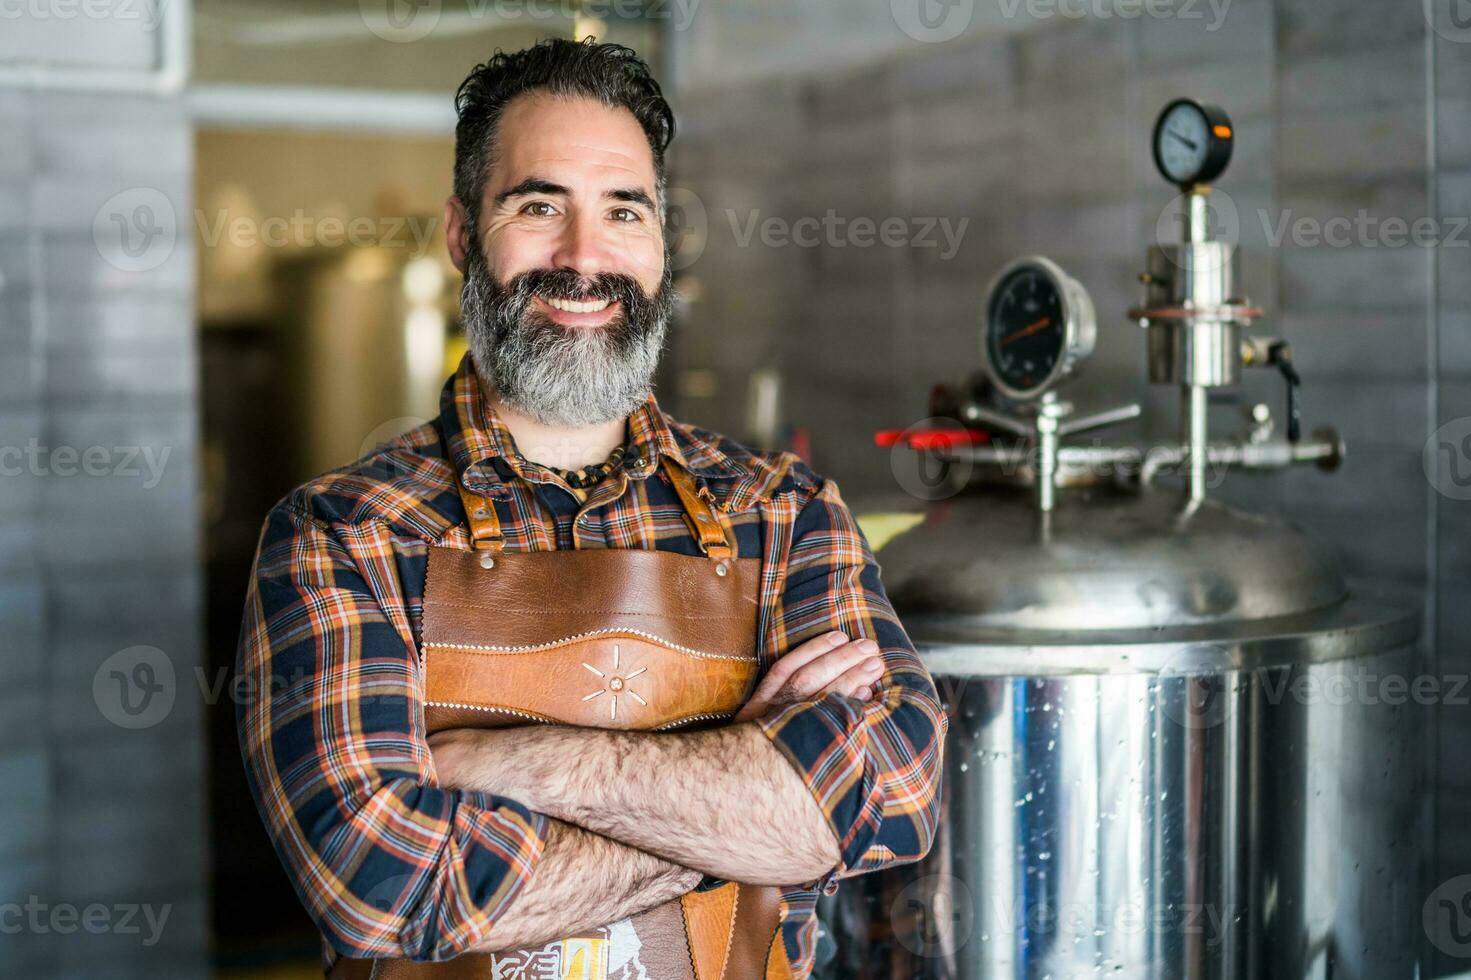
[237,481,946,959]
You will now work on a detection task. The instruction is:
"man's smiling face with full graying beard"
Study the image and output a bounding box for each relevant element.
[452,93,672,425]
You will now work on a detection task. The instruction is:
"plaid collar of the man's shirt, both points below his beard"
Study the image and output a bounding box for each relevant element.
[440,352,750,480]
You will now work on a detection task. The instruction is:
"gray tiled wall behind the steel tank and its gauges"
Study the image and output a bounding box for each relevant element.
[672,0,1471,971]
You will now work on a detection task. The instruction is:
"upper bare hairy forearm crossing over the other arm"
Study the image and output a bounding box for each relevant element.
[441,724,838,884]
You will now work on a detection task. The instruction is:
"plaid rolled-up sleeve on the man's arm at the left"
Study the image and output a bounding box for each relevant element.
[235,500,547,961]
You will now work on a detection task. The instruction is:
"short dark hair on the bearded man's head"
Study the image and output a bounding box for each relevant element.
[455,37,674,239]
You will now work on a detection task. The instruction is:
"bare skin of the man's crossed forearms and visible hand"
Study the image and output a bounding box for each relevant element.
[428,634,881,951]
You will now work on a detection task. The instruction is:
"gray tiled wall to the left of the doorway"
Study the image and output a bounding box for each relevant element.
[0,4,207,980]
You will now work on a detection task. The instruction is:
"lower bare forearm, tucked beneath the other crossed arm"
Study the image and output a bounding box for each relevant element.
[474,820,700,952]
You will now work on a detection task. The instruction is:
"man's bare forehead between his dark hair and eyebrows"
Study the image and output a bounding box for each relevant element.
[485,91,655,194]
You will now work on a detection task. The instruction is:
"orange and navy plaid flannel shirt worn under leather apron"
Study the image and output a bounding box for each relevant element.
[237,348,947,977]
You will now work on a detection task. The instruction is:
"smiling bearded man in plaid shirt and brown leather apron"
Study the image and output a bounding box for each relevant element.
[229,41,946,980]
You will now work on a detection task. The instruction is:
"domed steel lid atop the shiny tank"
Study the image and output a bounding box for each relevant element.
[861,489,1347,632]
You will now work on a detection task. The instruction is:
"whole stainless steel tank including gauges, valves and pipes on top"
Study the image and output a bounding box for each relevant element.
[819,99,1437,980]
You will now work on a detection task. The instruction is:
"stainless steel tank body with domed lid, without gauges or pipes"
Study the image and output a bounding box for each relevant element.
[821,486,1425,980]
